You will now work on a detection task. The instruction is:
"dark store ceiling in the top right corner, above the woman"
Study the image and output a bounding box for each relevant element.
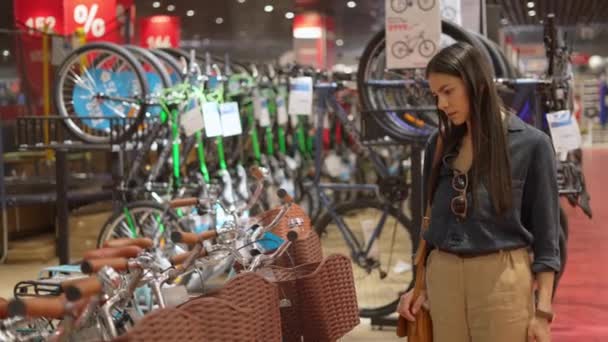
[487,0,608,26]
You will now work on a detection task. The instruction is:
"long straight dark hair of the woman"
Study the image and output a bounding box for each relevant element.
[426,43,512,215]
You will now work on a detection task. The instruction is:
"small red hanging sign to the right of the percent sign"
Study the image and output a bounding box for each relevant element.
[139,15,181,48]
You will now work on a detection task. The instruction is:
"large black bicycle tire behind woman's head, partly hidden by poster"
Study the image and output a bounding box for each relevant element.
[357,20,494,143]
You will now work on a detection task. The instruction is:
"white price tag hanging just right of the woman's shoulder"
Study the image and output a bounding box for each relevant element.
[547,110,582,154]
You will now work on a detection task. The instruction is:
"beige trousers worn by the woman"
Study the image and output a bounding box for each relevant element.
[427,249,534,342]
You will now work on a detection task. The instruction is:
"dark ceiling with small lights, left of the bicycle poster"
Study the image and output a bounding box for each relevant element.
[136,0,384,59]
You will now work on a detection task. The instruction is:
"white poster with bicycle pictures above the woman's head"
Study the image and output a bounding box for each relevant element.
[386,0,441,69]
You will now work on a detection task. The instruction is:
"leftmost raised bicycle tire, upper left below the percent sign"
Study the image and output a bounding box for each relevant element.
[53,42,148,144]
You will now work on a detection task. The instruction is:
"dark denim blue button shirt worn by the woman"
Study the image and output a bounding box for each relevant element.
[423,115,560,273]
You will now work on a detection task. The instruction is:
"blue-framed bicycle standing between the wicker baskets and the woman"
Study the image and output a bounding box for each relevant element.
[304,83,417,317]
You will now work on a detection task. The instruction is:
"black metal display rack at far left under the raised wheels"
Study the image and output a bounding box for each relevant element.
[0,115,147,264]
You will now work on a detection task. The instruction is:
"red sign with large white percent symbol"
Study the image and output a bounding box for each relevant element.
[63,0,121,42]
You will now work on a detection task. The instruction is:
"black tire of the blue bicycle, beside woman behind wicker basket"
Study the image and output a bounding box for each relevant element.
[315,199,418,317]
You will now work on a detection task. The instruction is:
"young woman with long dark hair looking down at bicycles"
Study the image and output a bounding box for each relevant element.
[398,43,560,342]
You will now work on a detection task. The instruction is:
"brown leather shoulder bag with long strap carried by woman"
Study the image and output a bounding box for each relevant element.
[397,136,443,342]
